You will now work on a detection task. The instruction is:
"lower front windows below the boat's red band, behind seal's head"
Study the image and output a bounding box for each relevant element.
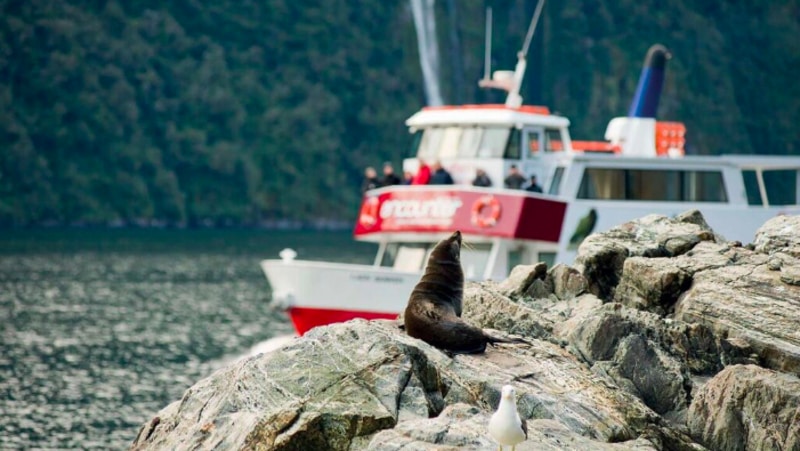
[381,243,491,279]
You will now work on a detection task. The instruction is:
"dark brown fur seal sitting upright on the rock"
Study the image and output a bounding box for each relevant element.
[403,231,527,354]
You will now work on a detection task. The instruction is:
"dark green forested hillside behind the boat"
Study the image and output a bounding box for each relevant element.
[0,0,800,226]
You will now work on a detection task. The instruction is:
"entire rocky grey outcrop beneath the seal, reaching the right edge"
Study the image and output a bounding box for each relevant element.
[132,212,800,450]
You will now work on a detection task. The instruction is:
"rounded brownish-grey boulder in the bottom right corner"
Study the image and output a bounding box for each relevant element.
[688,365,800,451]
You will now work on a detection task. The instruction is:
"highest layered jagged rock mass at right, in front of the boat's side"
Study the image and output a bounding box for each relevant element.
[578,213,800,374]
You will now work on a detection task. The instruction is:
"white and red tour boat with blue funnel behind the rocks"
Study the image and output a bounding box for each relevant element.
[261,39,800,334]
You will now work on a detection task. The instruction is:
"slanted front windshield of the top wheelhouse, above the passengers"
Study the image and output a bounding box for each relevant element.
[412,125,520,161]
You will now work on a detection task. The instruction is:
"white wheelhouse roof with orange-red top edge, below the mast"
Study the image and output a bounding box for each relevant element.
[406,105,569,128]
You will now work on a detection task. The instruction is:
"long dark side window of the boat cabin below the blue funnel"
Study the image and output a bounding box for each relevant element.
[578,168,728,202]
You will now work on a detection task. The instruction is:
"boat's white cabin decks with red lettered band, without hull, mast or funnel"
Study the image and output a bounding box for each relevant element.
[355,105,800,280]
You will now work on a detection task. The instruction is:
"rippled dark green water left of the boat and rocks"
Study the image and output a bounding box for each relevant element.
[0,230,374,449]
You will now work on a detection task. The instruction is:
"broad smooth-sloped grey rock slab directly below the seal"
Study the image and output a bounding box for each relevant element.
[133,320,658,449]
